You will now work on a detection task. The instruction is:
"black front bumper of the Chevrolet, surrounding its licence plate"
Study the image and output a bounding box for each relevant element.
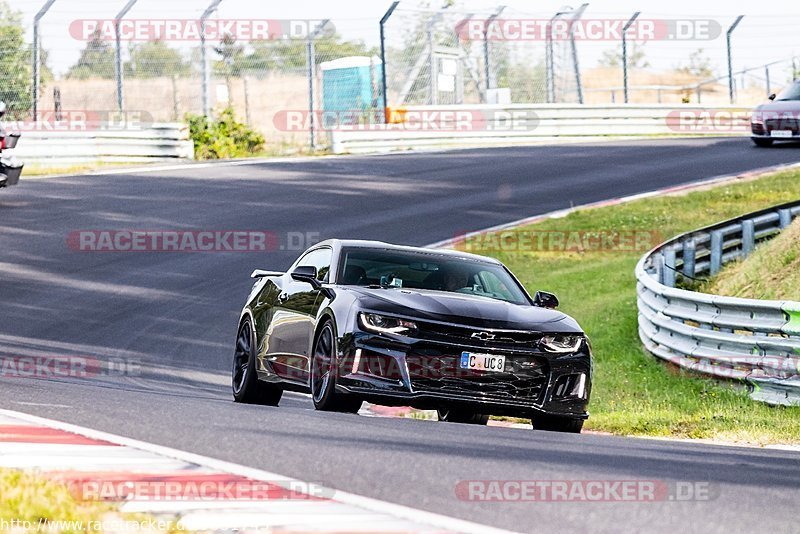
[337,331,592,419]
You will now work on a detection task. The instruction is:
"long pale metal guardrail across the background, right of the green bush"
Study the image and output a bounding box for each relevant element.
[323,104,750,154]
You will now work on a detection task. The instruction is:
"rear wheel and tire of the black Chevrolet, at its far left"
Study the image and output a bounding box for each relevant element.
[231,318,283,406]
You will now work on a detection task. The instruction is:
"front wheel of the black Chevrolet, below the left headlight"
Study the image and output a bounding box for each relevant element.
[310,321,363,413]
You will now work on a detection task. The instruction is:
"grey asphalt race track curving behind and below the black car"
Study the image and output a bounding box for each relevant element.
[0,139,800,533]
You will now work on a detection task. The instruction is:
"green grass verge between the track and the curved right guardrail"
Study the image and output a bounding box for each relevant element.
[467,171,800,444]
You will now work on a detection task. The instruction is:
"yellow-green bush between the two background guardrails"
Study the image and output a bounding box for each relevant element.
[186,107,265,159]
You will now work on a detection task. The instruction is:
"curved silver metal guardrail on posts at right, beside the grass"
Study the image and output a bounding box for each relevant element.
[636,201,800,404]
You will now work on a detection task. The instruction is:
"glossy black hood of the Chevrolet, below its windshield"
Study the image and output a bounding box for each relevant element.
[340,286,582,333]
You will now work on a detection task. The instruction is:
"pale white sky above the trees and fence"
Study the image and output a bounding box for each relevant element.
[7,0,800,85]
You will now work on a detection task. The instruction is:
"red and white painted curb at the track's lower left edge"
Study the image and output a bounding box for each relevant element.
[0,410,507,533]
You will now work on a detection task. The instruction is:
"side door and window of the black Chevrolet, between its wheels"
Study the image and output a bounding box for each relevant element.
[266,247,332,384]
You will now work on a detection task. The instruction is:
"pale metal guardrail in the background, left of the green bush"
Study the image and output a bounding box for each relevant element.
[8,123,194,167]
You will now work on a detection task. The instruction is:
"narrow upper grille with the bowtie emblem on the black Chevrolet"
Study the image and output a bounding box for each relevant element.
[415,322,542,348]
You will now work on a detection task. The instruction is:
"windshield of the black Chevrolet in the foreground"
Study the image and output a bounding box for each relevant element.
[339,249,530,304]
